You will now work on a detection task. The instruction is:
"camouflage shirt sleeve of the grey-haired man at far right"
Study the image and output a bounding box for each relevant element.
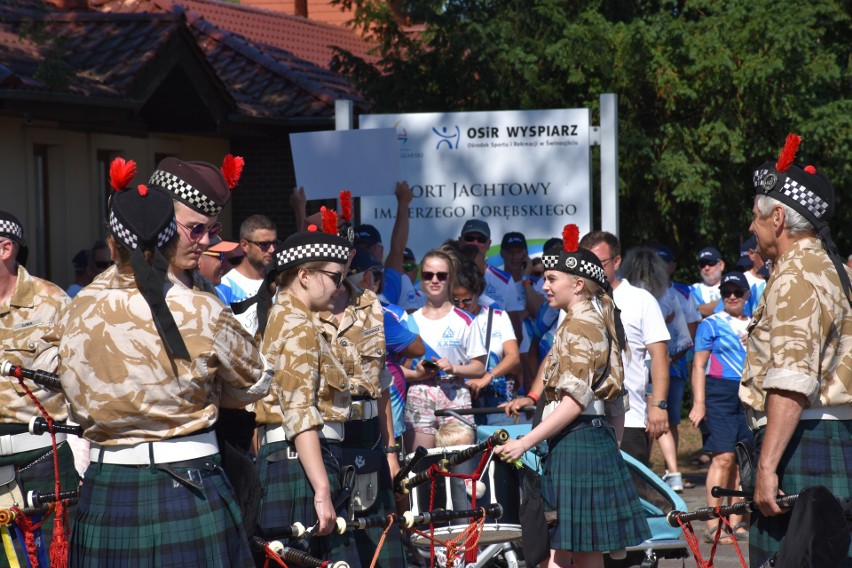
[763,273,825,404]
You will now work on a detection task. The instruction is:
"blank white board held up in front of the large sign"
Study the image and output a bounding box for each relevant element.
[290,128,402,199]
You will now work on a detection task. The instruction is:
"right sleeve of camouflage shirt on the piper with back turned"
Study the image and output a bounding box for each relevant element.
[213,310,272,404]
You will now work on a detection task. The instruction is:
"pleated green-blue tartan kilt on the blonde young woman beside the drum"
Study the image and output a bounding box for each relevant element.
[542,417,651,552]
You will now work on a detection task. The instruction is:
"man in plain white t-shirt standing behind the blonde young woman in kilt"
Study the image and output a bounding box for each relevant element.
[580,231,669,465]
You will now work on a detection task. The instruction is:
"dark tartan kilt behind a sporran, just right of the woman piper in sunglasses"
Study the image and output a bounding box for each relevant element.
[343,418,406,568]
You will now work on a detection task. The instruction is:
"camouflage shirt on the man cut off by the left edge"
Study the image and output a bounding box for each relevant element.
[0,266,71,424]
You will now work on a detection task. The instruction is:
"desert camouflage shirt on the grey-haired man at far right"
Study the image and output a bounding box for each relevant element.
[740,238,852,411]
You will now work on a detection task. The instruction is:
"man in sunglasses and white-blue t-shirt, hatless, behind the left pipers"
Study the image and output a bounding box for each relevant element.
[216,215,278,335]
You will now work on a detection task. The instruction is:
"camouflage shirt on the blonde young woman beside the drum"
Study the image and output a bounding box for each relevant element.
[544,301,624,408]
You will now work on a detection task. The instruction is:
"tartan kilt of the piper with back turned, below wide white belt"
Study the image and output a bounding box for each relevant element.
[68,454,253,568]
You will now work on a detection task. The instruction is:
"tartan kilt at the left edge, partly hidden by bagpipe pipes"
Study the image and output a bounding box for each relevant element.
[0,442,80,568]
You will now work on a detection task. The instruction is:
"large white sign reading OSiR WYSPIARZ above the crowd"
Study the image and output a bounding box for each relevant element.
[360,109,592,259]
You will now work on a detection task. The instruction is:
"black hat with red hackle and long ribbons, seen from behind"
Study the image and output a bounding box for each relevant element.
[109,158,189,359]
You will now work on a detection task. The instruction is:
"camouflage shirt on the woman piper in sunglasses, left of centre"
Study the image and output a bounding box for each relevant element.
[256,292,351,438]
